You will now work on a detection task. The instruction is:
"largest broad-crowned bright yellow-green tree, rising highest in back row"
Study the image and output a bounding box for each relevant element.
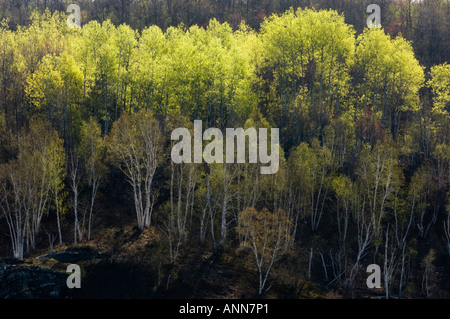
[258,8,355,149]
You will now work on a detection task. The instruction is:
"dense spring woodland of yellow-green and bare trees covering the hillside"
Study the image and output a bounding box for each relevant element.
[0,0,450,298]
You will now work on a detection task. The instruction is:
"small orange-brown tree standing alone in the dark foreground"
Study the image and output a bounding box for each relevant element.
[237,207,292,295]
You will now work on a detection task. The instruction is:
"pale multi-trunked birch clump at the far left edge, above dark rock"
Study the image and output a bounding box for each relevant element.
[0,118,56,258]
